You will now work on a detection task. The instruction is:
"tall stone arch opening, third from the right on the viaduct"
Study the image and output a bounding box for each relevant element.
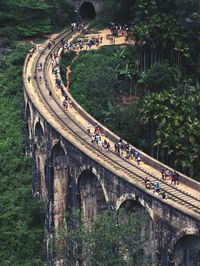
[78,169,107,223]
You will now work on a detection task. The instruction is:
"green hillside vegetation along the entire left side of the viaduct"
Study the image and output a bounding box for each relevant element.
[0,0,73,266]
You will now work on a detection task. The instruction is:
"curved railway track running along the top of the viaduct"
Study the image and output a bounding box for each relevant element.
[24,24,200,219]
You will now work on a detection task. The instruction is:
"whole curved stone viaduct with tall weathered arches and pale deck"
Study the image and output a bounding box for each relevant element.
[23,24,200,266]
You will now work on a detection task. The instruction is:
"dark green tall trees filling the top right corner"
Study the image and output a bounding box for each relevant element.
[131,0,200,79]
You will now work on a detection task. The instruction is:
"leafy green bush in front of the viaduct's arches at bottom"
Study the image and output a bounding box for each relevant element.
[57,209,148,266]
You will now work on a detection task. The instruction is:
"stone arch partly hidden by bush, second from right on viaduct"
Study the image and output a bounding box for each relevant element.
[116,194,158,265]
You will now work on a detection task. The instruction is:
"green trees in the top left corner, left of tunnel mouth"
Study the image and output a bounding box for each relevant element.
[0,0,74,47]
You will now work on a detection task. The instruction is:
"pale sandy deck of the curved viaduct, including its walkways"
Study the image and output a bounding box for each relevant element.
[24,26,200,219]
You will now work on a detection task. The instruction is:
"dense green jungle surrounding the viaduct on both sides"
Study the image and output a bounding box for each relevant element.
[0,0,200,266]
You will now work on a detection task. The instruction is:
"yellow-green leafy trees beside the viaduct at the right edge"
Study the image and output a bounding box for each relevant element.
[139,84,200,178]
